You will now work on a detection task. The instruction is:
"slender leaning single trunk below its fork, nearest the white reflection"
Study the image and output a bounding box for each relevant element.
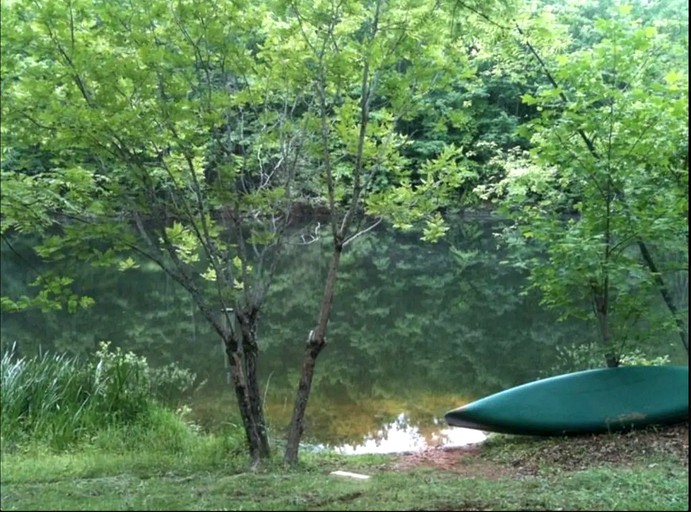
[283,244,343,464]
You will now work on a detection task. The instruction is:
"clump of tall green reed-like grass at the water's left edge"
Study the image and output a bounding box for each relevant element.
[0,343,155,450]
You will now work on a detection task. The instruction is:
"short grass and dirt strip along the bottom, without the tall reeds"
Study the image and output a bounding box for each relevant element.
[1,425,688,510]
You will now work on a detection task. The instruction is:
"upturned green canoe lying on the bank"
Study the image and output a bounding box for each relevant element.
[445,366,689,436]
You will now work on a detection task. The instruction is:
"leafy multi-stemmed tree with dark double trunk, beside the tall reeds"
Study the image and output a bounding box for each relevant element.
[2,1,310,462]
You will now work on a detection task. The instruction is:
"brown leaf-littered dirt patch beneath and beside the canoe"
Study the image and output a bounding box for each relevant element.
[394,422,689,478]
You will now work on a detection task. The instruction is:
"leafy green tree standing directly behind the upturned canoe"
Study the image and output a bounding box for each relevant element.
[484,2,688,366]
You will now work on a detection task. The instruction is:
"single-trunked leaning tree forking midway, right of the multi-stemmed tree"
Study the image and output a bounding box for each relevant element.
[274,0,506,463]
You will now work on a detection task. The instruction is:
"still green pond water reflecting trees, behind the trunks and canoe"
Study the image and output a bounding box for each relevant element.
[1,220,688,453]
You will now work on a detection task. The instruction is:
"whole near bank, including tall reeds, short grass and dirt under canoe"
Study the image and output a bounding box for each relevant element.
[0,346,688,510]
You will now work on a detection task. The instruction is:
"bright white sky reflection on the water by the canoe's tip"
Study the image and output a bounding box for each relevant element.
[335,413,487,455]
